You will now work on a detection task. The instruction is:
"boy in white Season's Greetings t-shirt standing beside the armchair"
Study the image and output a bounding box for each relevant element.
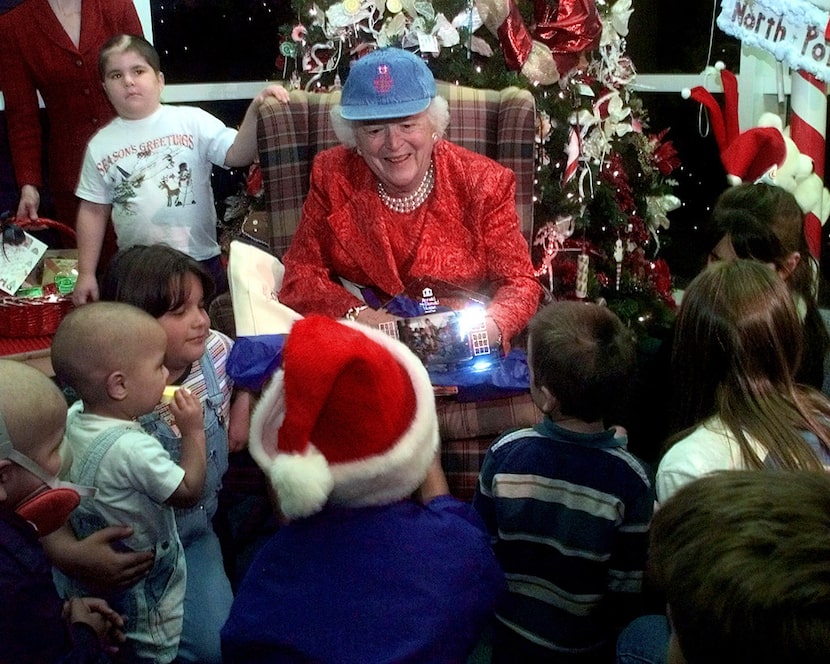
[73,35,288,304]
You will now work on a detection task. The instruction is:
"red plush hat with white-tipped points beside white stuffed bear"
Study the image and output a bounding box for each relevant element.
[682,62,787,185]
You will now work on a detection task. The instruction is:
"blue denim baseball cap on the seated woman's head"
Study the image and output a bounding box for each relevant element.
[340,48,435,120]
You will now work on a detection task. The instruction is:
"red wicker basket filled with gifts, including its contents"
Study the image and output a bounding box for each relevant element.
[0,218,77,338]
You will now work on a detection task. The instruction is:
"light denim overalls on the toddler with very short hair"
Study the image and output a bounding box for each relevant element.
[54,427,186,664]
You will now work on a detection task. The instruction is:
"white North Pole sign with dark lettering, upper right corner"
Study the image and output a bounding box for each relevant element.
[718,0,830,82]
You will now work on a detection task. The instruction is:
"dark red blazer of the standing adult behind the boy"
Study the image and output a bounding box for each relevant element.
[0,0,144,197]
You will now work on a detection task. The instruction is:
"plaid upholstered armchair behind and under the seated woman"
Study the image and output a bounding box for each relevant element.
[257,81,540,500]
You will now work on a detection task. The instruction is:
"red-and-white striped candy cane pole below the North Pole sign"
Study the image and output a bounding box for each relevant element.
[790,71,827,259]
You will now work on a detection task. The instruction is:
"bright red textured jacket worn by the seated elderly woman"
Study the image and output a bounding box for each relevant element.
[279,140,542,340]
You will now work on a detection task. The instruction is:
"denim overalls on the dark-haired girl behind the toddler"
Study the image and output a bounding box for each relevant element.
[139,351,233,664]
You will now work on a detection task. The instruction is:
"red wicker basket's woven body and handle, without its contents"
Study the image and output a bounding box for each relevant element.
[0,218,75,337]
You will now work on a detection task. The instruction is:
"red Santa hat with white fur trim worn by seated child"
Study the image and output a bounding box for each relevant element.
[249,316,439,519]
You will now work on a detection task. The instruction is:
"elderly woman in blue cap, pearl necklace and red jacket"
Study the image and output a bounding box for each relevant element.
[279,48,541,346]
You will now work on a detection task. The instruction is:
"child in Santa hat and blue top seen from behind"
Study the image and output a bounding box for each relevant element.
[222,316,504,664]
